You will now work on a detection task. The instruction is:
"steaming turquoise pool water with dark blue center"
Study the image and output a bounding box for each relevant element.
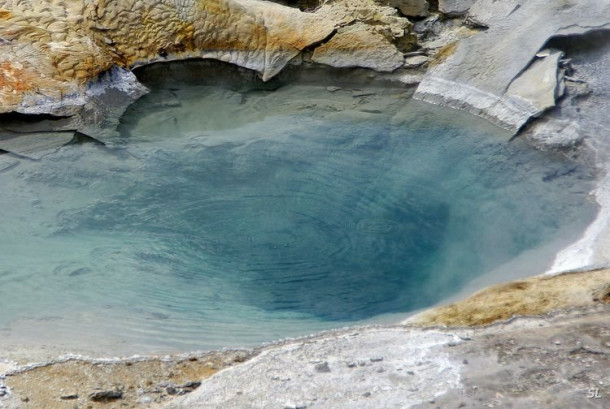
[0,72,596,352]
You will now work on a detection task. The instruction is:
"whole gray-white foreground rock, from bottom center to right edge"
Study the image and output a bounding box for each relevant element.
[162,306,610,409]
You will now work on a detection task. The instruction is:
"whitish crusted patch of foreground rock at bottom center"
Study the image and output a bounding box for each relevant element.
[159,328,459,409]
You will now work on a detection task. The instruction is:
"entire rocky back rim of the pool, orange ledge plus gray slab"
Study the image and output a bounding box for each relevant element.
[0,0,610,132]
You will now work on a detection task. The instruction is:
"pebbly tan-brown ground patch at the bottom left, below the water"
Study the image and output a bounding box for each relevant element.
[5,351,252,409]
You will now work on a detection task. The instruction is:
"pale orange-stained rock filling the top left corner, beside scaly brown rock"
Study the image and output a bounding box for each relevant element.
[0,0,113,114]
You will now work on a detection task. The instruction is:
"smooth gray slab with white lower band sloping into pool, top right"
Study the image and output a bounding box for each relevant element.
[415,0,610,132]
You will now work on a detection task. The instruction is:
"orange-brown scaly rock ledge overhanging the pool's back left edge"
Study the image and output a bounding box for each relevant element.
[0,0,410,115]
